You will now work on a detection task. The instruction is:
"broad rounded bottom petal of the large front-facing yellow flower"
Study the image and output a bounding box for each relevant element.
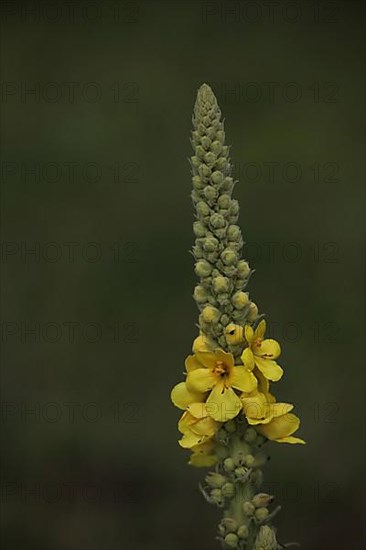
[206,380,242,422]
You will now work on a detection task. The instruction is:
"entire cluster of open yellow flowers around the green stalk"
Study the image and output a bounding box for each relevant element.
[171,320,304,466]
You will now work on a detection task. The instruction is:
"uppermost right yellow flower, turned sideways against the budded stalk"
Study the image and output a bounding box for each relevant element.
[241,320,283,382]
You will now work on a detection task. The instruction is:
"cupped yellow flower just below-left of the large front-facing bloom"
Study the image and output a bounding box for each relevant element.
[178,403,220,449]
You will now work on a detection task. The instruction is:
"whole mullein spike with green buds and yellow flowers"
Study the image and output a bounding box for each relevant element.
[171,84,304,550]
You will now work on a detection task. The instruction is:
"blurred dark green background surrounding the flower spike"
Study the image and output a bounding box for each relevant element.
[1,0,365,550]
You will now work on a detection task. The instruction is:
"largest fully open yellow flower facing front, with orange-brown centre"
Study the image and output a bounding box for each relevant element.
[186,349,257,422]
